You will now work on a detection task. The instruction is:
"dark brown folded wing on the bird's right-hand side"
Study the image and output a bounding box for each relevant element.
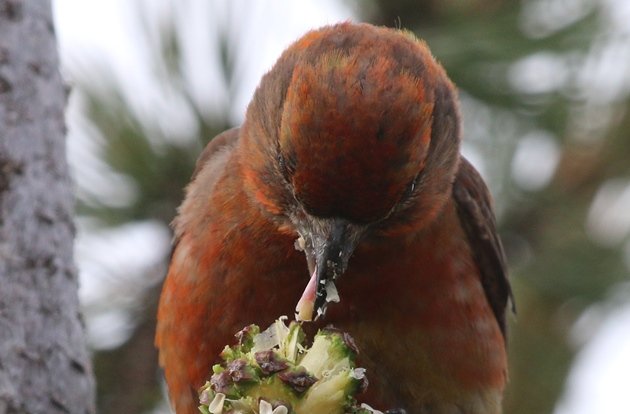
[453,157,514,337]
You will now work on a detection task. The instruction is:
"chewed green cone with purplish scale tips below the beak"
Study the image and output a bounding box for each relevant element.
[199,318,379,414]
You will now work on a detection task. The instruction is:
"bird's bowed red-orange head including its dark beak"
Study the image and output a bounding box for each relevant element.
[241,23,460,320]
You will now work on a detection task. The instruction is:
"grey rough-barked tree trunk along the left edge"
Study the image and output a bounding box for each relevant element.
[0,0,94,414]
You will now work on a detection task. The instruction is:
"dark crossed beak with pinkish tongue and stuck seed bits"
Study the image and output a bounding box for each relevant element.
[296,218,363,321]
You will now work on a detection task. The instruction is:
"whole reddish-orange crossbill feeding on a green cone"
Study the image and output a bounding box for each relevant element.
[156,22,513,414]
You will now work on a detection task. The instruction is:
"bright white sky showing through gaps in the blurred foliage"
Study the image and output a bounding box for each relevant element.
[53,0,630,414]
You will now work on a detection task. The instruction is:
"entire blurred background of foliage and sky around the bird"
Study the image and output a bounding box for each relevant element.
[53,0,630,414]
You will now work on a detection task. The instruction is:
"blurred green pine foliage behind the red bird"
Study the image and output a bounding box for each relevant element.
[66,0,630,414]
